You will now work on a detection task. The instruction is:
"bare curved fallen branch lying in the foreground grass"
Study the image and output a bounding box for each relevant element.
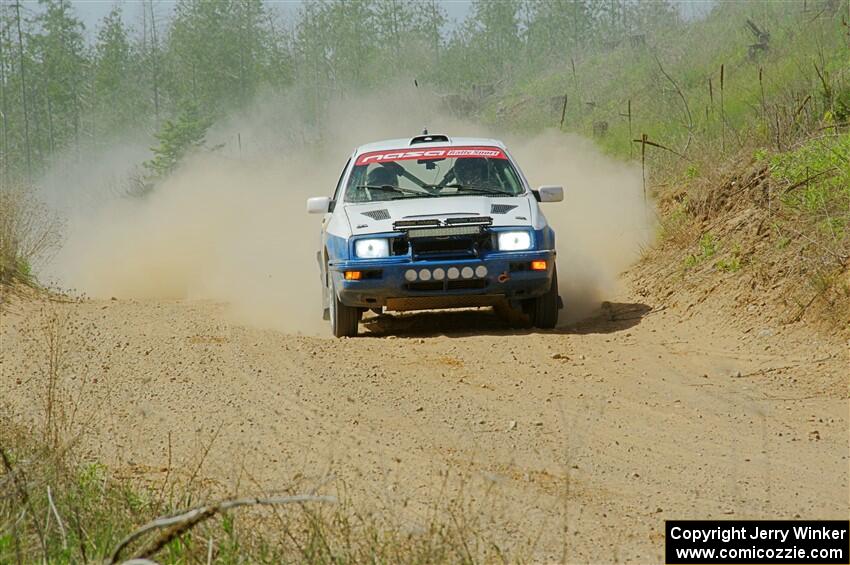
[109,494,336,565]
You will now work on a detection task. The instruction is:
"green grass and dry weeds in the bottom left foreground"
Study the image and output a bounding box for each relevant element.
[0,428,512,564]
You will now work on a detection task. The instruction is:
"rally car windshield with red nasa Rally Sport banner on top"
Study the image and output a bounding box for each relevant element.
[345,147,524,202]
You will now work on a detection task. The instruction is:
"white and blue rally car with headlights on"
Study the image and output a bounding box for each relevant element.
[307,131,564,337]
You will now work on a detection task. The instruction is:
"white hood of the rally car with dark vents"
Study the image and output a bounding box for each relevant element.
[344,196,531,235]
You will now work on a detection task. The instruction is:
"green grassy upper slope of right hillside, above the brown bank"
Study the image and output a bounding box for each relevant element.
[485,1,850,168]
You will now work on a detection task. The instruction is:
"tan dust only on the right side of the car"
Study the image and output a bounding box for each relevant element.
[506,131,655,324]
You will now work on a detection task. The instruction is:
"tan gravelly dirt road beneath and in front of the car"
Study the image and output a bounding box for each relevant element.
[0,276,850,563]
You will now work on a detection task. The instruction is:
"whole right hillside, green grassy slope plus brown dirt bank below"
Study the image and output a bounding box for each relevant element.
[484,0,850,312]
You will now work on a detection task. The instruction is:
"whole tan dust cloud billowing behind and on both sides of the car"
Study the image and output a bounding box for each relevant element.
[46,89,651,335]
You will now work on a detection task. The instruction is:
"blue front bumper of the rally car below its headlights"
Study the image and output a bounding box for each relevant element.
[329,250,555,310]
